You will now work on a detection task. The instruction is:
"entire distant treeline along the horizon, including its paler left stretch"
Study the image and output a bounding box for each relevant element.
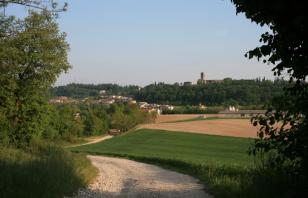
[53,78,287,106]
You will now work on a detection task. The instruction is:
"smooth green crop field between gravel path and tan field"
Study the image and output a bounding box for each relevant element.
[74,129,252,165]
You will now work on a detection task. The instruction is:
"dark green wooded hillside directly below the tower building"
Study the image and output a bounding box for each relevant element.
[135,78,286,106]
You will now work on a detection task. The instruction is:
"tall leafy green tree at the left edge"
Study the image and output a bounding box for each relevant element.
[0,10,70,146]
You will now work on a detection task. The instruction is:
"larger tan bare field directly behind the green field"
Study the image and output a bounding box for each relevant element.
[141,118,258,138]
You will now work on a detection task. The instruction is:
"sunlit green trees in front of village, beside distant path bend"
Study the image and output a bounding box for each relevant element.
[42,104,156,141]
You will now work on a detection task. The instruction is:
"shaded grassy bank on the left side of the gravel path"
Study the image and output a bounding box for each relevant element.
[0,143,97,198]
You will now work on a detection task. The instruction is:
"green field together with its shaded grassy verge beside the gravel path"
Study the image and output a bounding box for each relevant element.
[72,129,294,198]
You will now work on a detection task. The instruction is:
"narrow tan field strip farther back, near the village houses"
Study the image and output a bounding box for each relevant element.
[155,114,221,123]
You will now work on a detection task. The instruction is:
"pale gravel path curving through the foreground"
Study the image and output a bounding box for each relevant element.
[75,156,212,198]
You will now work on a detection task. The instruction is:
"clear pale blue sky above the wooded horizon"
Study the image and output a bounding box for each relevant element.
[7,0,274,86]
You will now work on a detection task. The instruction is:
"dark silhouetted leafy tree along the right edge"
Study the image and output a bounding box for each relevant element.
[231,0,308,193]
